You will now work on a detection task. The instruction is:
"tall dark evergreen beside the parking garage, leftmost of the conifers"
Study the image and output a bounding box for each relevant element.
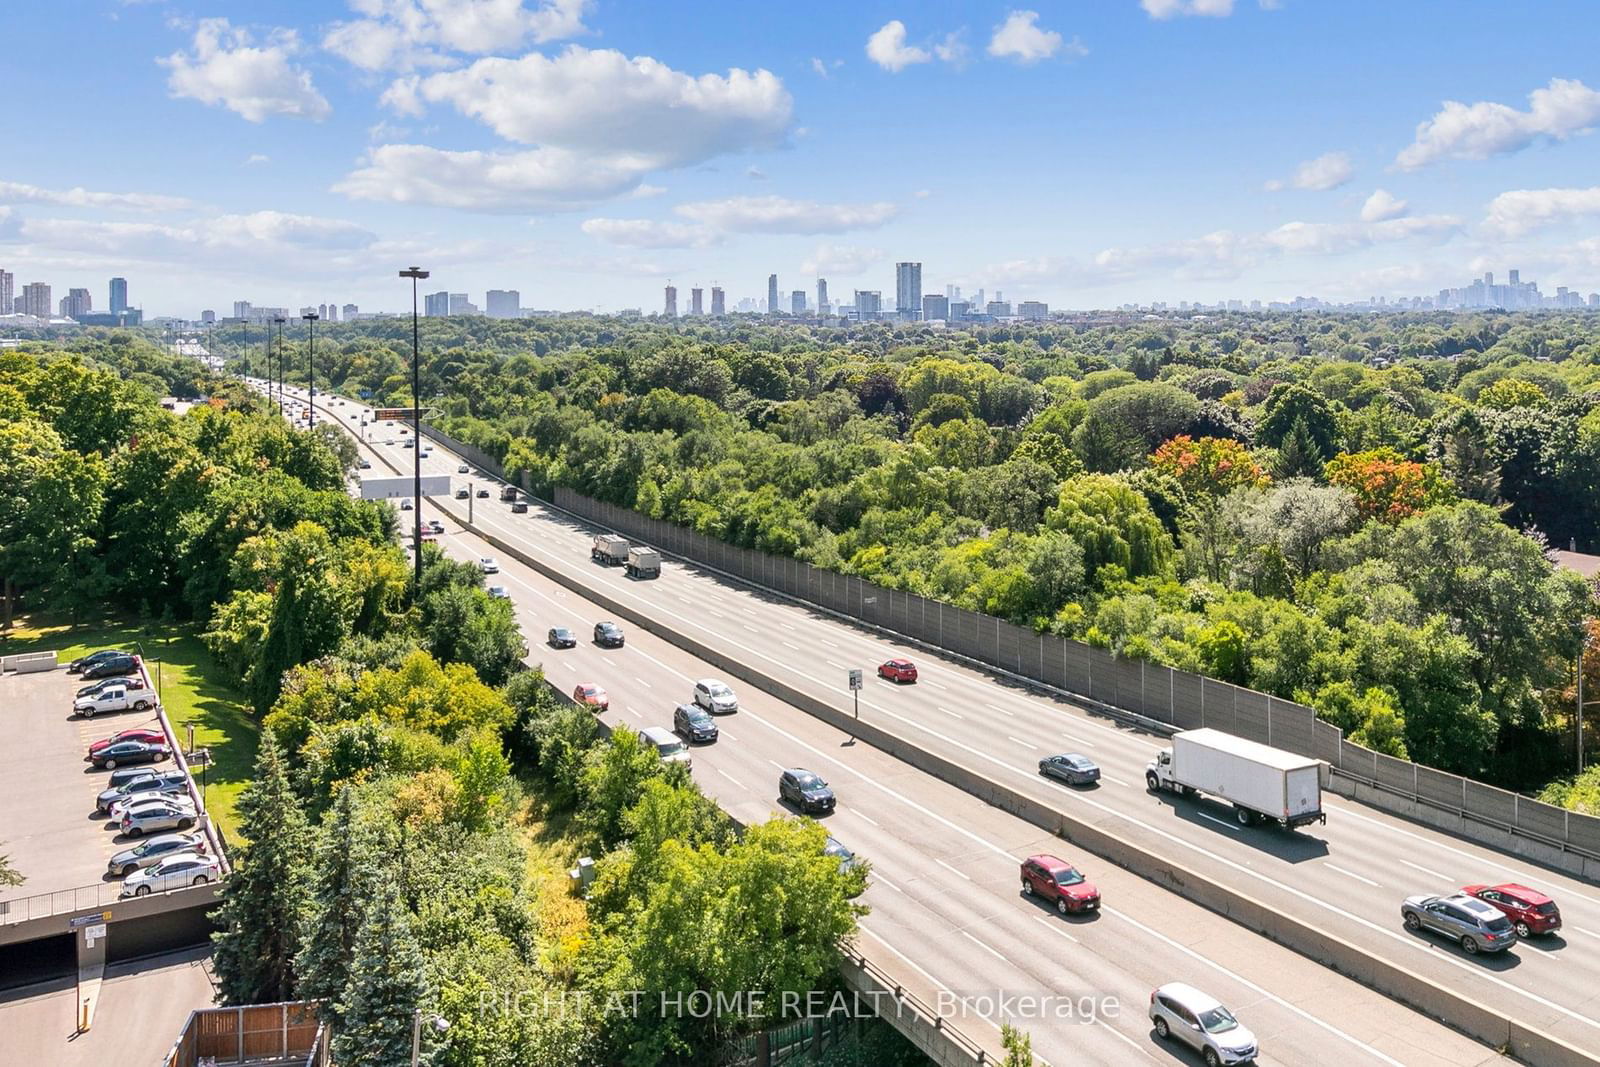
[211,731,310,1005]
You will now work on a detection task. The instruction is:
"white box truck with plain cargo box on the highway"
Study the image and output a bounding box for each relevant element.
[1144,729,1328,830]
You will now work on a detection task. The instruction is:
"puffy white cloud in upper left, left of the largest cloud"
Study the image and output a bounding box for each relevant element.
[157,19,333,122]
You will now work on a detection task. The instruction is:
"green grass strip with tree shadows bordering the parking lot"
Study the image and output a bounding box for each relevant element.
[0,613,261,841]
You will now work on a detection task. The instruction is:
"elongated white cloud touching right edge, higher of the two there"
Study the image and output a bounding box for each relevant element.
[1395,78,1600,171]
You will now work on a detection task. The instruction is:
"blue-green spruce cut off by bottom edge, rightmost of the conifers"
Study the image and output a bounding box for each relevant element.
[333,867,429,1067]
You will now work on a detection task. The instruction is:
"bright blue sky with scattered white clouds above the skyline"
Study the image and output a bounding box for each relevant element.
[0,0,1600,315]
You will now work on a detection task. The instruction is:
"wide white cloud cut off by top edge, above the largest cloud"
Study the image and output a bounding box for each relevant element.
[322,0,590,70]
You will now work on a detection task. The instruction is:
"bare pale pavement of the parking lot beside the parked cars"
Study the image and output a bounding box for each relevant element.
[0,667,171,923]
